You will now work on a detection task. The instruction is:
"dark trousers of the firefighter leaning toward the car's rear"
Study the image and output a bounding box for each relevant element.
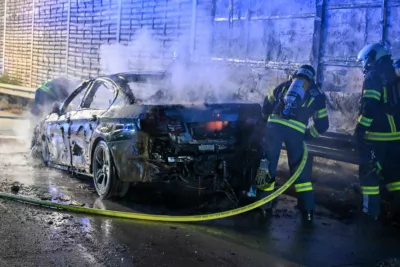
[258,122,315,211]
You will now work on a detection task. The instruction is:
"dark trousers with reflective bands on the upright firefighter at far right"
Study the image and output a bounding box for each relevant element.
[359,141,400,217]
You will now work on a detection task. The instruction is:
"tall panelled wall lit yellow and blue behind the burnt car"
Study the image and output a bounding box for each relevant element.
[0,0,400,133]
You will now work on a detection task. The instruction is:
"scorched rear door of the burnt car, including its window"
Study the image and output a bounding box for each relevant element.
[70,79,118,172]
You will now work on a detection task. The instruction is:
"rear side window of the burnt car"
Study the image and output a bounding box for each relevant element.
[84,81,115,109]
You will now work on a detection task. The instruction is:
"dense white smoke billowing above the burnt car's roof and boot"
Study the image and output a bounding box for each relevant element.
[100,29,244,104]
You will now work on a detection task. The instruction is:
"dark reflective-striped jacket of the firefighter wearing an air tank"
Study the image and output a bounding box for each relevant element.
[262,80,329,139]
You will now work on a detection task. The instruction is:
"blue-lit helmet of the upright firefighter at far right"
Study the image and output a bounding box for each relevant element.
[357,43,390,73]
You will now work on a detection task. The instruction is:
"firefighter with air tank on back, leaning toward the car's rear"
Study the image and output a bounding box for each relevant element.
[255,65,329,221]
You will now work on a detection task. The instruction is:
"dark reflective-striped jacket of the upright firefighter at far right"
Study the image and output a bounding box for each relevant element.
[356,56,400,141]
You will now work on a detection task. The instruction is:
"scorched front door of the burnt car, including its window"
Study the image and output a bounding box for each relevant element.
[46,83,87,166]
